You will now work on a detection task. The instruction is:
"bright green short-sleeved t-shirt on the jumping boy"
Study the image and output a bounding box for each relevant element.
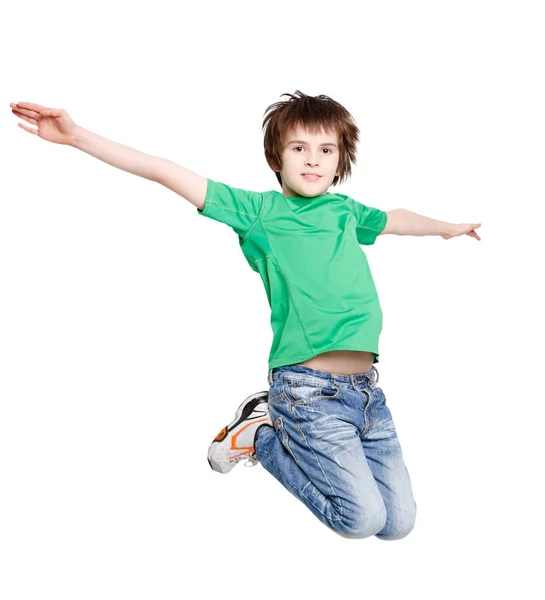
[197,179,387,369]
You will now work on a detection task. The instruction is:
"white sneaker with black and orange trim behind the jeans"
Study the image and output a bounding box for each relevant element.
[208,392,273,473]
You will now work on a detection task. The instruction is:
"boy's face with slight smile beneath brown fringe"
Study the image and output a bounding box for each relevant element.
[280,125,339,198]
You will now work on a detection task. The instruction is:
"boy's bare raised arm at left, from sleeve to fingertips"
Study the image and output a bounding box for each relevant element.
[10,102,207,210]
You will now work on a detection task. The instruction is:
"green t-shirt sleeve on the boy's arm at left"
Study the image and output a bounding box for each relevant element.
[197,179,263,238]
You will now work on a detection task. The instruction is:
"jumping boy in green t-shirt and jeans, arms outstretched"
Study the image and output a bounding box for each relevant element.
[11,90,480,540]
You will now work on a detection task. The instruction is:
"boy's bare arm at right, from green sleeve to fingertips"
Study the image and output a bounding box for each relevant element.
[379,208,481,240]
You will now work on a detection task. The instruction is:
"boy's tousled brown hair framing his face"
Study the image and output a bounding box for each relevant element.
[263,90,359,185]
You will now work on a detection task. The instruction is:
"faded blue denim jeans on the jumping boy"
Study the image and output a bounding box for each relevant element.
[254,365,416,540]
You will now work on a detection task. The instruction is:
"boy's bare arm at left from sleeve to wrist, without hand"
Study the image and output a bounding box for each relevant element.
[72,125,207,210]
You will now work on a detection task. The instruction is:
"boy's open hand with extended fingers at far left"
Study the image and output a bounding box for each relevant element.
[10,102,77,145]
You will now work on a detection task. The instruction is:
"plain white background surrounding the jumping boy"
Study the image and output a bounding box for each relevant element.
[0,0,545,600]
